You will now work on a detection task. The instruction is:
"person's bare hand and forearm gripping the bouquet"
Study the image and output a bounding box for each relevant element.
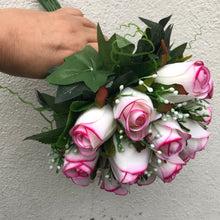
[0,8,98,79]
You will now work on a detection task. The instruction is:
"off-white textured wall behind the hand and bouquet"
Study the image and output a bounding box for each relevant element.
[0,0,220,220]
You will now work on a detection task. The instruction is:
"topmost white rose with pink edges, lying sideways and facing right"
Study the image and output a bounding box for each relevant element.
[155,61,213,102]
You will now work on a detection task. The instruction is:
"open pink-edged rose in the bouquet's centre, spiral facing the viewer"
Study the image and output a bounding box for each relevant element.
[113,88,159,141]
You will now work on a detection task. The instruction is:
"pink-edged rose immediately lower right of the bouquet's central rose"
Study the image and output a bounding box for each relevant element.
[146,117,191,160]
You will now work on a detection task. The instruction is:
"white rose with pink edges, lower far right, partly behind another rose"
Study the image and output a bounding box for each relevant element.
[180,119,211,162]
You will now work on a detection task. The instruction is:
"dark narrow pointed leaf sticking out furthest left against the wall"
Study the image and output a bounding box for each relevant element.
[24,128,64,144]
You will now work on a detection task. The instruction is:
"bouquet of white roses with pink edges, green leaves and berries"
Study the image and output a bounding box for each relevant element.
[23,1,213,195]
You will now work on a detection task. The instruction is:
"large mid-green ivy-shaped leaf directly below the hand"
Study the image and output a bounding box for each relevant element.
[46,46,113,92]
